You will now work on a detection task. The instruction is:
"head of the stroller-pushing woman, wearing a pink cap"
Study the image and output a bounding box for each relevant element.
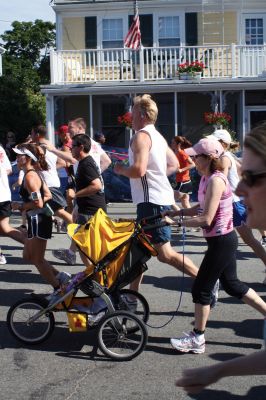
[185,138,224,176]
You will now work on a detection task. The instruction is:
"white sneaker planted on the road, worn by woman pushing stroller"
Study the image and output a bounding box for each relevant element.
[170,331,205,354]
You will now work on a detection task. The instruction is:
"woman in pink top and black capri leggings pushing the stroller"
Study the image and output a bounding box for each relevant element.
[168,139,266,353]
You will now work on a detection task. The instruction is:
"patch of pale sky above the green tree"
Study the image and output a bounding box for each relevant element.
[0,0,55,35]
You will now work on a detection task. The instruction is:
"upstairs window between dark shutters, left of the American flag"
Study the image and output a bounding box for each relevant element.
[102,18,124,49]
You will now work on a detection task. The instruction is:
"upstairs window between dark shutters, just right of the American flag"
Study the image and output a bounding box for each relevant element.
[159,16,180,47]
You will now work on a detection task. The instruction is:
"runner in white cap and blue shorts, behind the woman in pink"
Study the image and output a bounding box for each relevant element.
[209,129,266,284]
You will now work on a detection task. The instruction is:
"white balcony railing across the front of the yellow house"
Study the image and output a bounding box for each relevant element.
[50,44,266,84]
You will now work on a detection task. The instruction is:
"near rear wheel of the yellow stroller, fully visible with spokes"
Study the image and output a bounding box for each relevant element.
[98,311,148,361]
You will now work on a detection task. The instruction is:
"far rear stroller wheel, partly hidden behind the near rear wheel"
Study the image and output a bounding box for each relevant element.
[118,289,150,332]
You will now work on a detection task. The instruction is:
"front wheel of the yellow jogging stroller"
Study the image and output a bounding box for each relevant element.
[7,298,55,344]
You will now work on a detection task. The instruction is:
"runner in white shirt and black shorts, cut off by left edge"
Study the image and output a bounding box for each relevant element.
[0,146,25,264]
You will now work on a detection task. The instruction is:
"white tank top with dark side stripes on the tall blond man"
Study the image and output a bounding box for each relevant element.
[128,124,175,206]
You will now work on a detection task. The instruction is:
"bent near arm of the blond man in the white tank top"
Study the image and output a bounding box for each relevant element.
[114,131,151,179]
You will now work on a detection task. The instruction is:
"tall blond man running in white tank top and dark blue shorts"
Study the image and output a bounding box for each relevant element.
[114,94,198,290]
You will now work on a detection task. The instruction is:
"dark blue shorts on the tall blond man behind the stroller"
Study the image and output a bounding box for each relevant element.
[137,203,171,244]
